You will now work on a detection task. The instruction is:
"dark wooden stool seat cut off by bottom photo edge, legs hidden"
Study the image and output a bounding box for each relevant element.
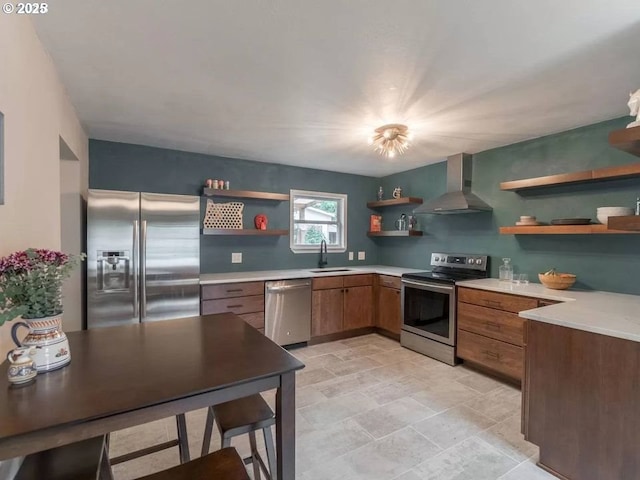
[138,448,250,480]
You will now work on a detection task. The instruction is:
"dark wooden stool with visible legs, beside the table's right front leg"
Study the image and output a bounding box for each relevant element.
[202,394,276,480]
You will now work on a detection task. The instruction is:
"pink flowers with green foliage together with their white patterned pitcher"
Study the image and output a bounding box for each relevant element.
[0,248,85,372]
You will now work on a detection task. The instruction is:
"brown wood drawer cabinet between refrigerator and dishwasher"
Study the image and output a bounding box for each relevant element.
[200,282,264,333]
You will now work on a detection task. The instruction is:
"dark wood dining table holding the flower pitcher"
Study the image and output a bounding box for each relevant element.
[0,313,304,480]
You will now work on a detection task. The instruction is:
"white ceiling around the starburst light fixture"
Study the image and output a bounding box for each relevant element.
[34,0,640,176]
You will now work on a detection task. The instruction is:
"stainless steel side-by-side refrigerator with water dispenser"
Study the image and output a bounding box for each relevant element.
[87,190,200,328]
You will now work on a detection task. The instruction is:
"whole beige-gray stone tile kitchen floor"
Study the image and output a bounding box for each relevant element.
[111,335,555,480]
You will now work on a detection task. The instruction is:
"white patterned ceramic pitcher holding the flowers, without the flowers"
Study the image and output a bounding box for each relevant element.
[11,313,71,373]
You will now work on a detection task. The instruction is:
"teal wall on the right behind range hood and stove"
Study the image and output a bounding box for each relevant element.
[377,117,640,294]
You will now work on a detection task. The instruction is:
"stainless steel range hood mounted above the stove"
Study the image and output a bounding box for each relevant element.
[413,153,493,215]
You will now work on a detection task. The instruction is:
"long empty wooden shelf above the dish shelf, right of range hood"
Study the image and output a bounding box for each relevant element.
[500,161,640,191]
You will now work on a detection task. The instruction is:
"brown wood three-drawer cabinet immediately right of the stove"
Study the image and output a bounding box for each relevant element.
[456,288,557,382]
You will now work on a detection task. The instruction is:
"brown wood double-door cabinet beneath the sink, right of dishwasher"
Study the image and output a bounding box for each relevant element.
[311,274,373,337]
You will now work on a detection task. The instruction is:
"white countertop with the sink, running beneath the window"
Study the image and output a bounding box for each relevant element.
[200,265,425,285]
